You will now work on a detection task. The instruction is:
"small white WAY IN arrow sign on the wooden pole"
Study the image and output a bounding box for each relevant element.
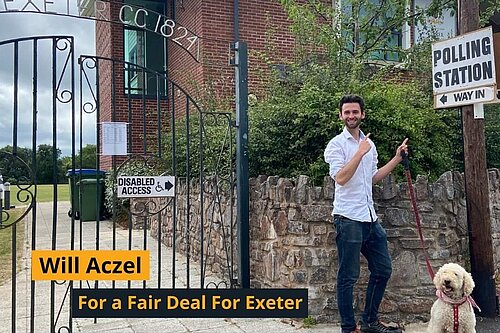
[434,87,495,108]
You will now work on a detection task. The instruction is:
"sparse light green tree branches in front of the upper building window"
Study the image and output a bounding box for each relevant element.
[280,0,456,78]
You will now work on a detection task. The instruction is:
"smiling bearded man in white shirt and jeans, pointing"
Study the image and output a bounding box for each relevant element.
[324,95,408,333]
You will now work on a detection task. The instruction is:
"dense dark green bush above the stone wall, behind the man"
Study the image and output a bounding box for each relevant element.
[250,80,454,183]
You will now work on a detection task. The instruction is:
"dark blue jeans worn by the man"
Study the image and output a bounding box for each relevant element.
[334,215,392,332]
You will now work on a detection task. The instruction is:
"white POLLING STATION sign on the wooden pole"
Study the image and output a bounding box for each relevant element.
[432,27,496,94]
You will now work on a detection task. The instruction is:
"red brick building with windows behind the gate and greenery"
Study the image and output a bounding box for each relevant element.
[82,0,466,167]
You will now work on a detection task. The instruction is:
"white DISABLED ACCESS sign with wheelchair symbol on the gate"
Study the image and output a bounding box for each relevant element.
[116,176,175,198]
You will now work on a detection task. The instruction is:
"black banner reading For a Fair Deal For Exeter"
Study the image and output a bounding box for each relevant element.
[71,289,308,318]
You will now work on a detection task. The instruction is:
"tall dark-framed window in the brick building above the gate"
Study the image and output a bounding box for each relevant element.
[123,0,167,97]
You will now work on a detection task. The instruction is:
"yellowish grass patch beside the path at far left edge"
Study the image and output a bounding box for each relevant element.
[0,208,24,284]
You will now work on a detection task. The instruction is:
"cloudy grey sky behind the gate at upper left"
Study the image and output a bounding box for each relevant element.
[0,0,96,156]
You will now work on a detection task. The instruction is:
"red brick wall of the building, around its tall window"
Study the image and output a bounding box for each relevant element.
[96,0,294,169]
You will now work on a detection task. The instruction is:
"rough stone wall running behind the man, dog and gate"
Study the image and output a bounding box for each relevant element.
[153,169,500,322]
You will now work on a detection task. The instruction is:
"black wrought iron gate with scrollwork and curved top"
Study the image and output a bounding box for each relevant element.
[0,36,243,332]
